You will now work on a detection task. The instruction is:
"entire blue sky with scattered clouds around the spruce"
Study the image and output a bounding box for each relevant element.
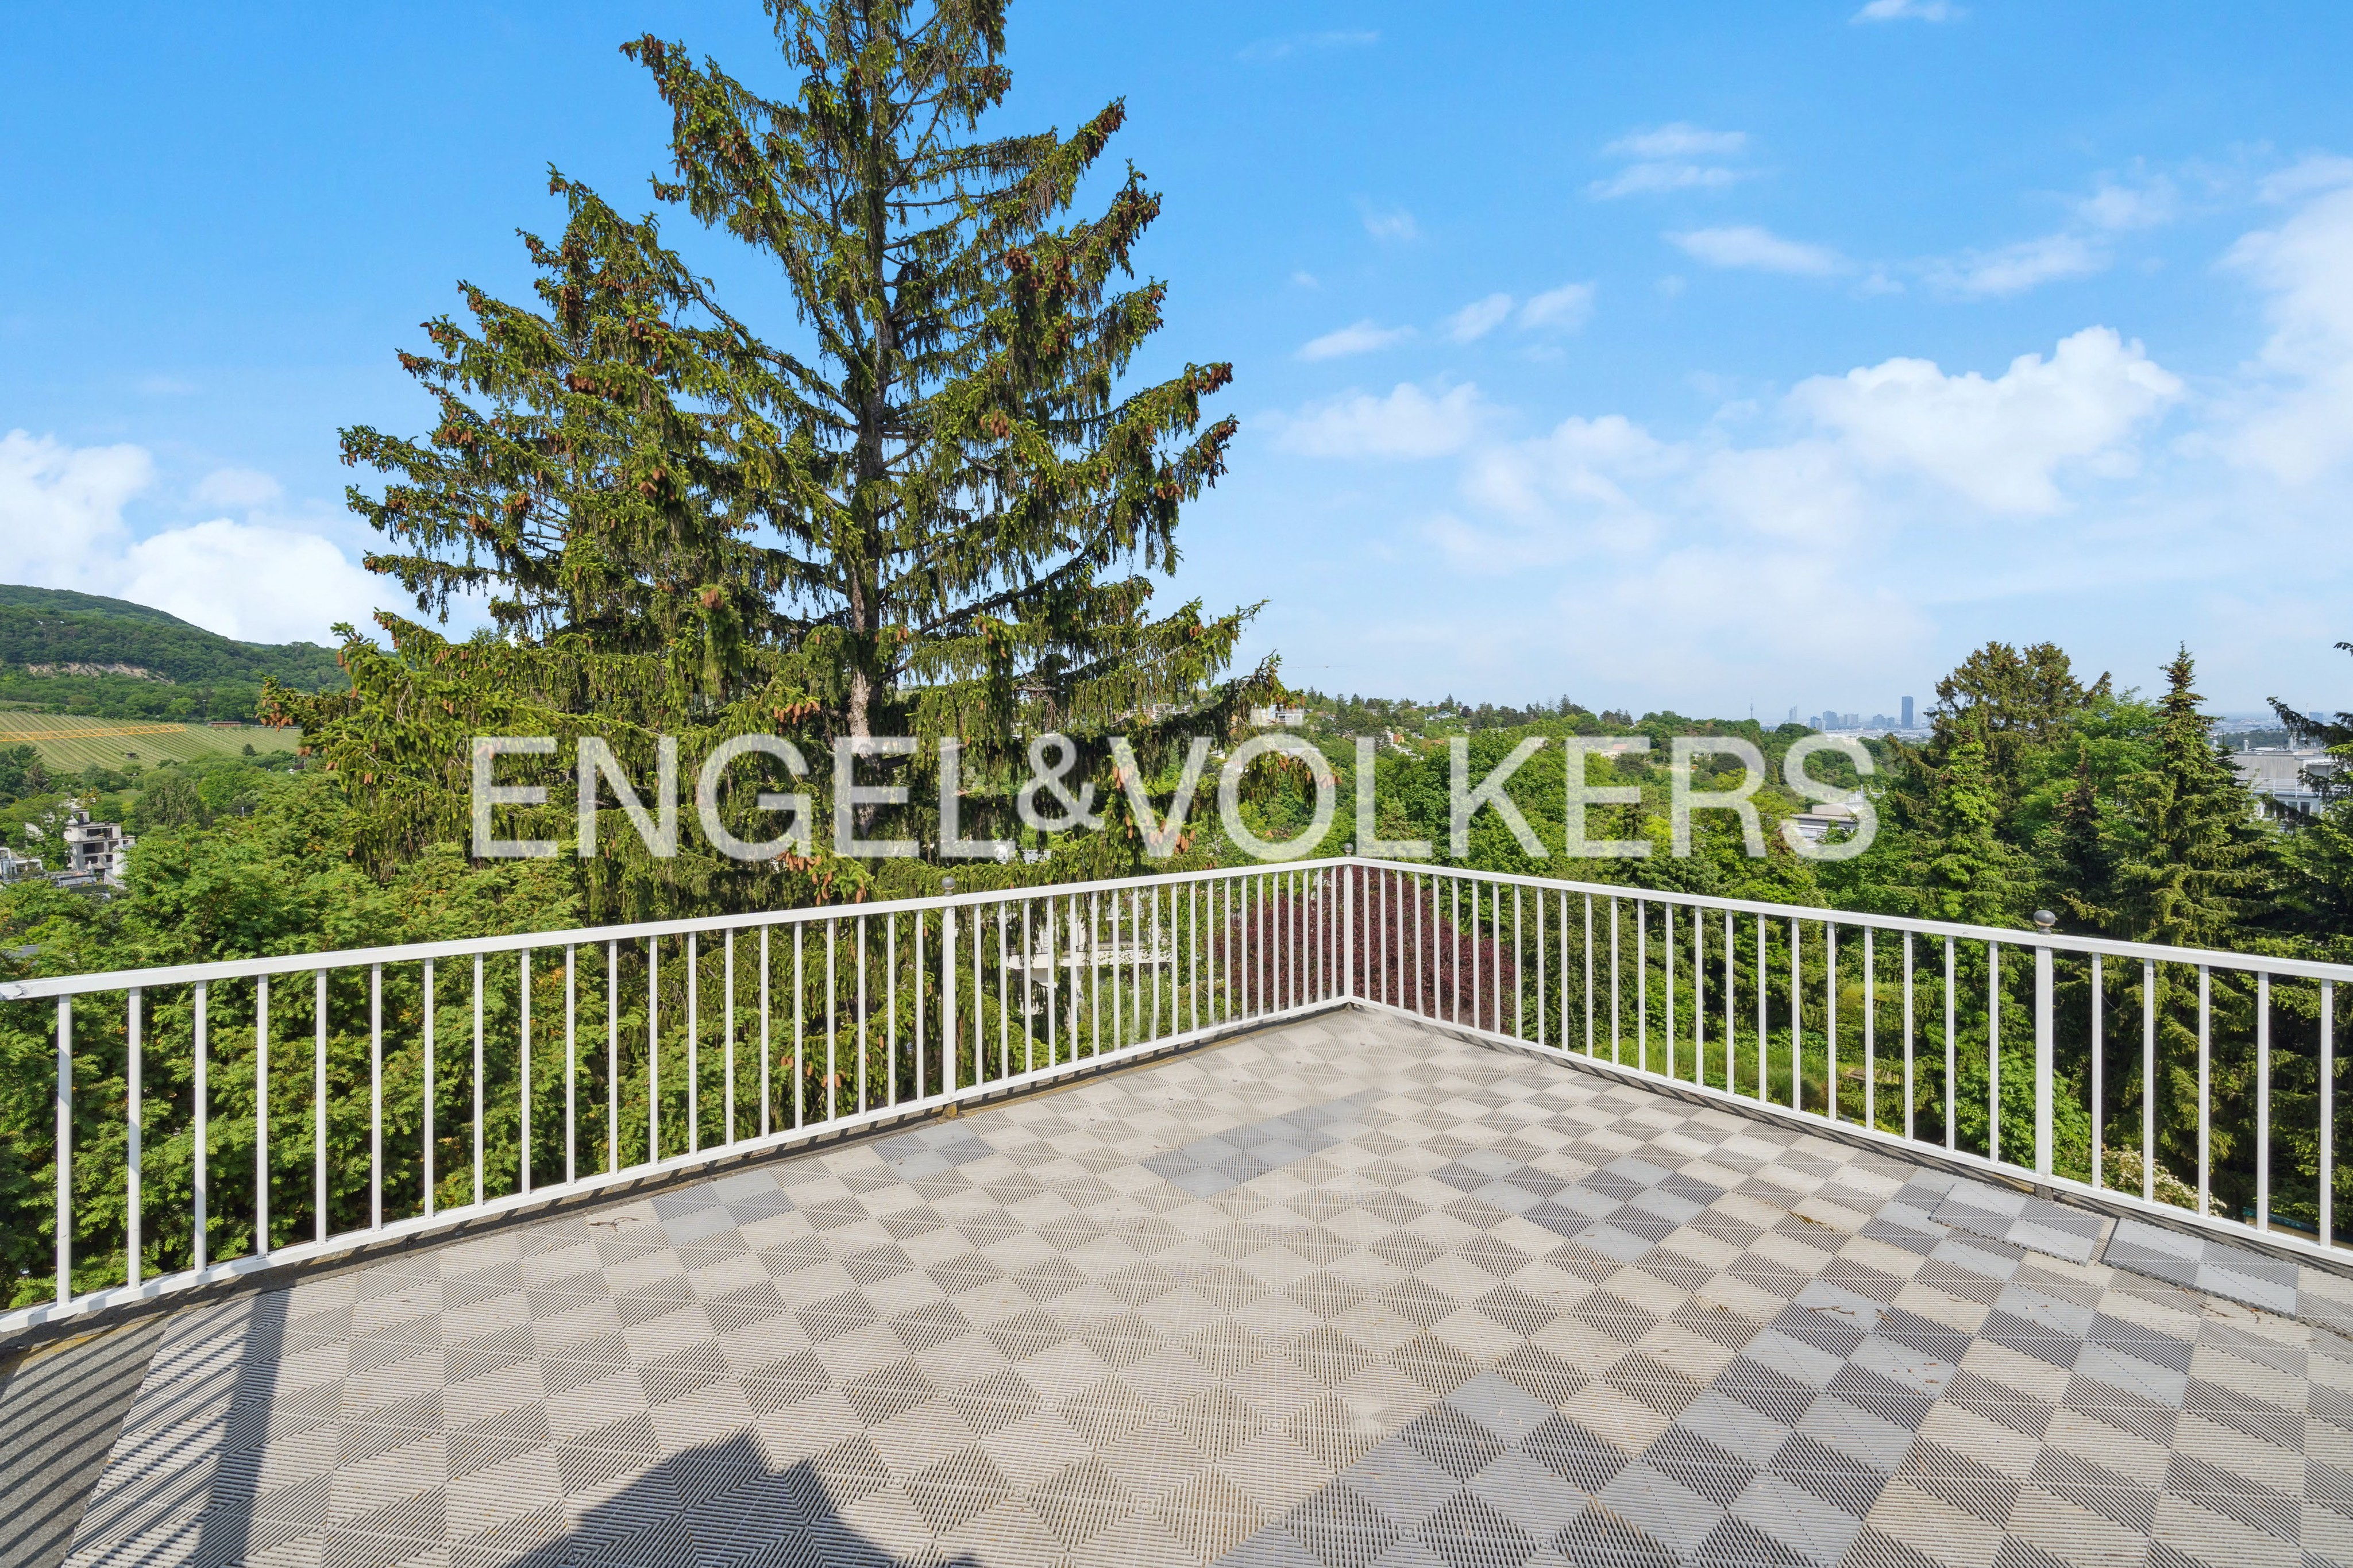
[0,0,2353,717]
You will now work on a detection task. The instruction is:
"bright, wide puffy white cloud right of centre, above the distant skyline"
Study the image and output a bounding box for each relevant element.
[1788,327,2184,512]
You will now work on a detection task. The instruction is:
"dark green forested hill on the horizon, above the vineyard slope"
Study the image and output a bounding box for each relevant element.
[0,583,344,691]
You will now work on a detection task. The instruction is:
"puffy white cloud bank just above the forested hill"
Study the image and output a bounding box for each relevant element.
[0,430,388,642]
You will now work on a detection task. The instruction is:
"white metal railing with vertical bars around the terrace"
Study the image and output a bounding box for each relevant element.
[0,858,2353,1333]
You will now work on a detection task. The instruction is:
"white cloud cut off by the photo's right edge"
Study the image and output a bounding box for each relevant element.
[2221,188,2353,484]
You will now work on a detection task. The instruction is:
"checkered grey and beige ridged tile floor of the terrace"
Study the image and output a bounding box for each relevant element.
[71,1013,2353,1568]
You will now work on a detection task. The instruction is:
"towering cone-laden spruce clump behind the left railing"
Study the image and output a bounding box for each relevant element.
[268,0,1273,912]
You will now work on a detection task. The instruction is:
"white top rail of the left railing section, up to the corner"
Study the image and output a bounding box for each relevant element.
[0,858,1348,1002]
